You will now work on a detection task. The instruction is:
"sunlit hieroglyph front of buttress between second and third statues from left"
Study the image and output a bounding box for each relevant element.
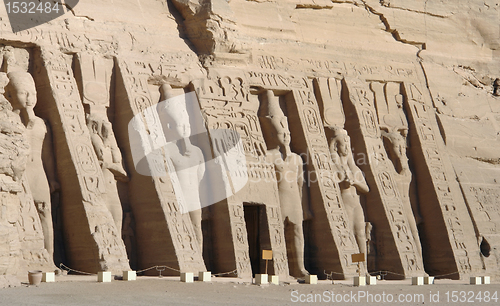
[117,59,206,271]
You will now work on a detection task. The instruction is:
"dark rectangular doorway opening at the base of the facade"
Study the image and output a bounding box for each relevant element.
[243,204,264,276]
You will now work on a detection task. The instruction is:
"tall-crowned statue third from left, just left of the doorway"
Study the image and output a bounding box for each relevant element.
[157,84,205,250]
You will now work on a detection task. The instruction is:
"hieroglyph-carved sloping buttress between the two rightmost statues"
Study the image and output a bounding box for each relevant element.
[344,78,424,276]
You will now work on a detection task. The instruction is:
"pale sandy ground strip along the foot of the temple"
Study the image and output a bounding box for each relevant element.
[0,275,500,305]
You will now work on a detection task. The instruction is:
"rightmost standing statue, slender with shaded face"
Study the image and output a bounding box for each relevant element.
[382,131,422,255]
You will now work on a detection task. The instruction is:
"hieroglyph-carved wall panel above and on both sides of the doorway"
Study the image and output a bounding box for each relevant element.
[193,71,280,276]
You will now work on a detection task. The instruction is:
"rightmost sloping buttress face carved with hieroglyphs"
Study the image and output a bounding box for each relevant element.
[404,82,482,277]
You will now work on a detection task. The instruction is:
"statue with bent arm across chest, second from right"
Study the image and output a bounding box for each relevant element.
[330,127,370,268]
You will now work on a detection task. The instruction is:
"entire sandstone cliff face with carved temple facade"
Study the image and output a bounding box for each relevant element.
[0,0,500,279]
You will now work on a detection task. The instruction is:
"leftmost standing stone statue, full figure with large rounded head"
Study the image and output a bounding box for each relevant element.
[7,70,59,258]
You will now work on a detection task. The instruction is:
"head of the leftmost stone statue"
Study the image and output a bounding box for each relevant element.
[6,71,36,110]
